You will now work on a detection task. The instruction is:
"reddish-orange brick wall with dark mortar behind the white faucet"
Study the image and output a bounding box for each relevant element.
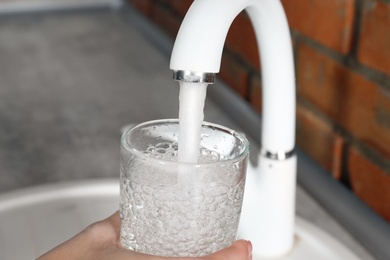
[129,0,390,222]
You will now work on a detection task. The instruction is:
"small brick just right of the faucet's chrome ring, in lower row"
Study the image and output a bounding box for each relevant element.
[297,103,345,176]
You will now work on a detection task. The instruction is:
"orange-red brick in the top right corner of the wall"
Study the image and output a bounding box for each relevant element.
[358,0,390,74]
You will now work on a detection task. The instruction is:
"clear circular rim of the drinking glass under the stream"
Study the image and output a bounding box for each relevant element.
[121,119,250,168]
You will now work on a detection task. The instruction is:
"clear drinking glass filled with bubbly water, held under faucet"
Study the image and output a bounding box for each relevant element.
[120,120,249,256]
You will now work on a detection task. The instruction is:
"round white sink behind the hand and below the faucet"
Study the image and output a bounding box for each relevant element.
[0,179,359,260]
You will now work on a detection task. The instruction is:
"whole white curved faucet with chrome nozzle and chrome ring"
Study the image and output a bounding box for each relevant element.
[170,0,297,257]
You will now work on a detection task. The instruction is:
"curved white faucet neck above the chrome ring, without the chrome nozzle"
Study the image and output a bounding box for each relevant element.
[170,0,295,154]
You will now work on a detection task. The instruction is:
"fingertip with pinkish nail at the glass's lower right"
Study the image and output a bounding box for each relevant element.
[204,240,252,260]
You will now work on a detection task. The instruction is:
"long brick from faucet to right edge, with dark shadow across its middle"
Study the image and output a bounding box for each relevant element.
[297,44,390,158]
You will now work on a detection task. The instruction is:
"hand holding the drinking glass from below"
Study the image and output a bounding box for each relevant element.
[38,212,252,260]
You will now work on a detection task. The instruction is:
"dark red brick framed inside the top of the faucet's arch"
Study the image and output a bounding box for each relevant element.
[225,12,260,70]
